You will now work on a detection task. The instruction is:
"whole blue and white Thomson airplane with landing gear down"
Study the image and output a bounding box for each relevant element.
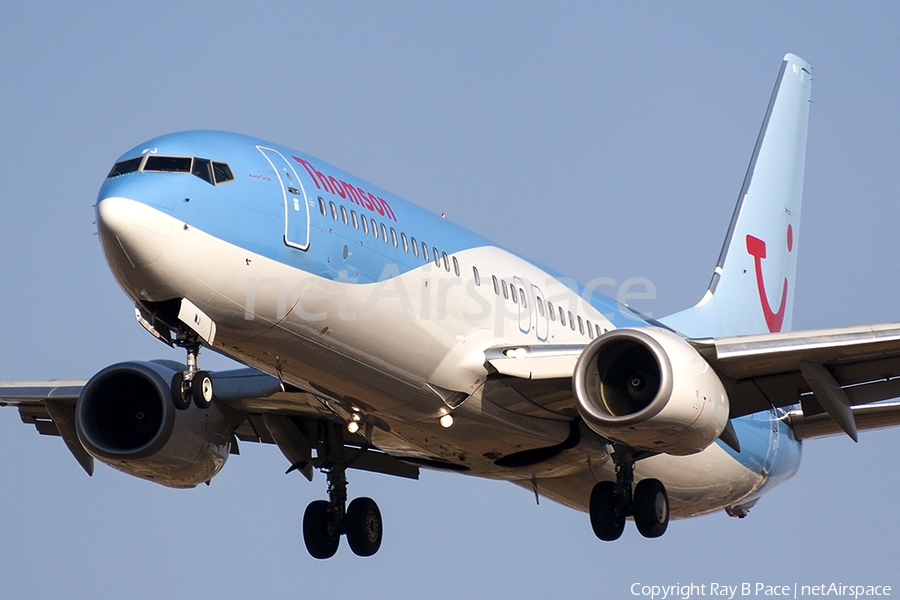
[0,54,900,559]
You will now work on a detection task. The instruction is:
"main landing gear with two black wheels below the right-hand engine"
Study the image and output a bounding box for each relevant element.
[590,445,669,542]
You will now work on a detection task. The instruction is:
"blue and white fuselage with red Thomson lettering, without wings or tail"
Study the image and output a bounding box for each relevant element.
[96,131,800,517]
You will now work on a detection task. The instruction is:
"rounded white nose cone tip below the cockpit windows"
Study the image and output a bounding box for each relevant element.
[97,196,173,268]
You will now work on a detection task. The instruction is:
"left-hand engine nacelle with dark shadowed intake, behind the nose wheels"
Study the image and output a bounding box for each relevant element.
[75,361,232,488]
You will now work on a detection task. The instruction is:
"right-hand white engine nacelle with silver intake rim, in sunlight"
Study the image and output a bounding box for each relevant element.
[574,327,729,455]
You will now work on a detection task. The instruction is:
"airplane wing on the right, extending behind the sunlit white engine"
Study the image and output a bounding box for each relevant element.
[485,323,900,440]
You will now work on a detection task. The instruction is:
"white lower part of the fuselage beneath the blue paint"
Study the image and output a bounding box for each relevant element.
[98,198,789,517]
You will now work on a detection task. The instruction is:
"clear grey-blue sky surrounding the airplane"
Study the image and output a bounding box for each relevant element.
[0,0,900,598]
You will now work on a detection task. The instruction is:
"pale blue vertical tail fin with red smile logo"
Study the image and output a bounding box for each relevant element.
[661,54,812,337]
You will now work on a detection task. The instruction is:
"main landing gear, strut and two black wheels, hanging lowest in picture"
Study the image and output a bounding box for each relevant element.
[303,424,383,559]
